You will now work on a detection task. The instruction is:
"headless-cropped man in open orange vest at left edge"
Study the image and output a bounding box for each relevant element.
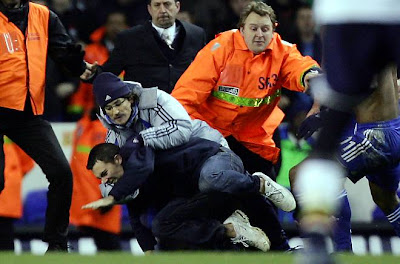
[0,0,96,252]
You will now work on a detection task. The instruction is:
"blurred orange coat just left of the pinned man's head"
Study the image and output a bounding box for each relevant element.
[70,115,121,234]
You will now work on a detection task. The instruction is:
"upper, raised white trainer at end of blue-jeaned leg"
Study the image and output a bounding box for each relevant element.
[253,172,296,212]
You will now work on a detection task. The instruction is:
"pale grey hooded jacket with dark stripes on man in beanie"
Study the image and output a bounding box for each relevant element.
[99,80,229,149]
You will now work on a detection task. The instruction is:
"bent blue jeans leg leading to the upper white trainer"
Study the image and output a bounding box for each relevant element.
[199,147,260,194]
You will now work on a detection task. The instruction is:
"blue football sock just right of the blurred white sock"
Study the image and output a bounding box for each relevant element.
[332,190,353,252]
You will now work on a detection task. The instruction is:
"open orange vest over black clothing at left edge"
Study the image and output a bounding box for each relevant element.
[0,3,50,115]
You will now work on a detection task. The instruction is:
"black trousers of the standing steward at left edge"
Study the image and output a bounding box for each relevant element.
[0,112,72,243]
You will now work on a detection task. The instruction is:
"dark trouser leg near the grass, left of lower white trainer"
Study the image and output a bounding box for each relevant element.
[152,192,238,250]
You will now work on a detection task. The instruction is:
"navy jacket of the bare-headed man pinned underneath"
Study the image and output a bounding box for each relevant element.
[109,136,221,251]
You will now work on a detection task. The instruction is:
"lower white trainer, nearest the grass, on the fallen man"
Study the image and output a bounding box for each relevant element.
[224,210,271,252]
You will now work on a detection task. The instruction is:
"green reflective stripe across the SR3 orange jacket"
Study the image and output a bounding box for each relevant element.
[212,89,281,107]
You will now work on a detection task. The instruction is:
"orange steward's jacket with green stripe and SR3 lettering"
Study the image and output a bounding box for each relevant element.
[171,30,319,162]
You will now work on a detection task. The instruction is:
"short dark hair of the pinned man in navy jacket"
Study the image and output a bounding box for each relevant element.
[86,143,120,170]
